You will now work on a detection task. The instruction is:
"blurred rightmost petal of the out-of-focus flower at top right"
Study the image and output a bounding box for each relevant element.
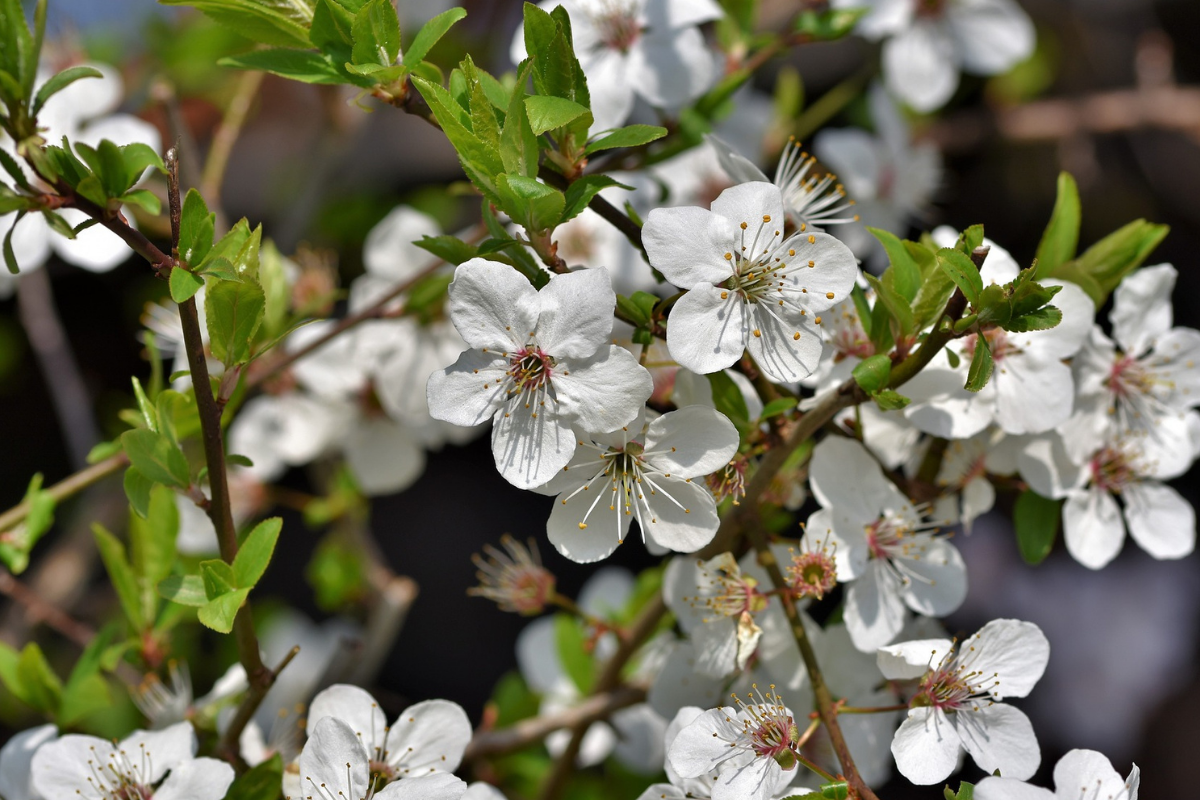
[946,0,1036,76]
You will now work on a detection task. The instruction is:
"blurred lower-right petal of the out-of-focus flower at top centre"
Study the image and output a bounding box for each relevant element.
[628,28,718,109]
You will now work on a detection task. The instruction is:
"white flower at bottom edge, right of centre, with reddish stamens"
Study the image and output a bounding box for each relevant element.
[667,684,799,800]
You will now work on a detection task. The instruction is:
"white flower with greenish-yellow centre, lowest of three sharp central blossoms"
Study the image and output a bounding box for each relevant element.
[538,405,738,563]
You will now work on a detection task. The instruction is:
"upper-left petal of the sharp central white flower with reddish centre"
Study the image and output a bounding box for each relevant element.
[449,258,541,353]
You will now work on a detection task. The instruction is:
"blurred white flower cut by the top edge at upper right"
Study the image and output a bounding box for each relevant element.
[833,0,1036,112]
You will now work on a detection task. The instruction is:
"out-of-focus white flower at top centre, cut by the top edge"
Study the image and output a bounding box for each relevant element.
[510,0,724,131]
